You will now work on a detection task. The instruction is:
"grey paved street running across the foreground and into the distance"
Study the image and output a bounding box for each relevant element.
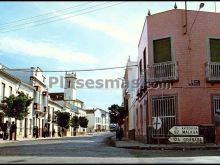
[0,133,220,164]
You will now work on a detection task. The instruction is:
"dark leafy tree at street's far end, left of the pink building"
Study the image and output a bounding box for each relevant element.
[108,104,127,125]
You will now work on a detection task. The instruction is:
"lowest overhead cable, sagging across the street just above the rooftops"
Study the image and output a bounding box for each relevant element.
[0,65,137,72]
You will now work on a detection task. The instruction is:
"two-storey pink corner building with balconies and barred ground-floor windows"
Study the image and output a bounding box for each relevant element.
[135,9,220,143]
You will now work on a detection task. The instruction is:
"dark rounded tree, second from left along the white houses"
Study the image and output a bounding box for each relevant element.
[56,111,70,129]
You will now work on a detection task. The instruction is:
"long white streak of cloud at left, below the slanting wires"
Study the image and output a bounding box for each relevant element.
[0,37,97,63]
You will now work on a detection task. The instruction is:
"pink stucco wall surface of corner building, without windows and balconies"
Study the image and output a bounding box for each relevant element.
[137,9,220,135]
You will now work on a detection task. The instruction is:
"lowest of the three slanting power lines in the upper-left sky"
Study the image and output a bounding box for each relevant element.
[0,2,124,33]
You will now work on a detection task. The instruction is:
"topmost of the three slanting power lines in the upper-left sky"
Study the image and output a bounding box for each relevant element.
[0,2,93,26]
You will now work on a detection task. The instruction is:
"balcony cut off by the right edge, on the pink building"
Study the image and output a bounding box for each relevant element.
[206,62,220,82]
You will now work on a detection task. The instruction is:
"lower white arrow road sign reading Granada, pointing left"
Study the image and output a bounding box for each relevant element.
[168,137,204,143]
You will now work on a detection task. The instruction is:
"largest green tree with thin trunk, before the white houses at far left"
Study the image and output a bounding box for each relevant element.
[2,92,33,140]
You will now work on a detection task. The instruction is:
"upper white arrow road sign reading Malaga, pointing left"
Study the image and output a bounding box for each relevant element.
[169,126,199,135]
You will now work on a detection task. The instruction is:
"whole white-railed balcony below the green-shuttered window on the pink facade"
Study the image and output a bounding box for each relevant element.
[147,61,178,83]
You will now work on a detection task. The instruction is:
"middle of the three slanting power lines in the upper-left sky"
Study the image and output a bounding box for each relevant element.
[0,2,109,30]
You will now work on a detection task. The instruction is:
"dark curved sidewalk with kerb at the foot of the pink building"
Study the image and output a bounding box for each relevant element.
[111,136,220,150]
